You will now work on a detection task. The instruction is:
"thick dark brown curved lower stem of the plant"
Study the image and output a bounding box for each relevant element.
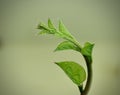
[80,56,92,95]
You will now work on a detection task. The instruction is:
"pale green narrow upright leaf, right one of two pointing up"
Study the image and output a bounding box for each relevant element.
[59,21,73,39]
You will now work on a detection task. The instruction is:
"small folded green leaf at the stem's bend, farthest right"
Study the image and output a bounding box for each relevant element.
[81,42,94,56]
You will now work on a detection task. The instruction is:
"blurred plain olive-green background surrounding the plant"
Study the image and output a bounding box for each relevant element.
[0,0,120,95]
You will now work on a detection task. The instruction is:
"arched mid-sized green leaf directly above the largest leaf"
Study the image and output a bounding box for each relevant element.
[55,41,79,51]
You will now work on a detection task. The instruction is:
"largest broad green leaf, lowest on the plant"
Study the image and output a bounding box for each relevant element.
[56,61,86,86]
